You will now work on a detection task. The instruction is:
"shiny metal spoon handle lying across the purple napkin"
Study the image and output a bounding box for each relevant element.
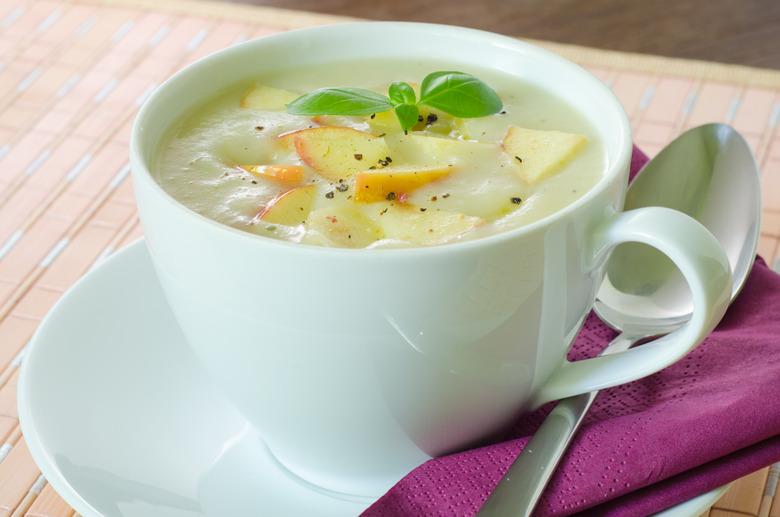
[477,334,642,517]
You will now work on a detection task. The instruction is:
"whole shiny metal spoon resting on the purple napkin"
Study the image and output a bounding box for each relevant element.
[477,124,761,517]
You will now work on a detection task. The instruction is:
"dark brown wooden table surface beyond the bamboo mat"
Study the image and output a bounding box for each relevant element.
[219,0,780,70]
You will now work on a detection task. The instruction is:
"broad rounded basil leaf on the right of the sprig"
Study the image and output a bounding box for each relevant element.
[418,72,503,118]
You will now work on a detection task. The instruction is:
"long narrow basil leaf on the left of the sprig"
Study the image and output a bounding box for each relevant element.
[286,88,393,116]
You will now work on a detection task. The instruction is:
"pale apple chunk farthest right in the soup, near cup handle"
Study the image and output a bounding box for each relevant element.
[503,126,586,183]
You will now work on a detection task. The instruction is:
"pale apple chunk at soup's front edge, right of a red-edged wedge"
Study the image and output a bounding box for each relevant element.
[304,203,384,248]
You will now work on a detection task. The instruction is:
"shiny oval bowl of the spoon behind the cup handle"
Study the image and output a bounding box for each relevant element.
[593,124,761,335]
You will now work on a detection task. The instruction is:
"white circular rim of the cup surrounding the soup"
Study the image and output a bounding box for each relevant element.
[129,21,633,255]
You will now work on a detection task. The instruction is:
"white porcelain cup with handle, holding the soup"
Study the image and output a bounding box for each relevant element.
[131,22,731,496]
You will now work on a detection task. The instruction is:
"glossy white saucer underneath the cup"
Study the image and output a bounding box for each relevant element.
[18,241,726,517]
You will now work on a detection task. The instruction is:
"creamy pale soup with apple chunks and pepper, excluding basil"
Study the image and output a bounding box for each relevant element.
[153,58,606,248]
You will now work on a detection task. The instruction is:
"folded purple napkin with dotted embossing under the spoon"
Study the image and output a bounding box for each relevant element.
[363,149,780,517]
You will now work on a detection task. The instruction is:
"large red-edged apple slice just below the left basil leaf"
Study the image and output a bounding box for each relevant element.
[284,126,390,180]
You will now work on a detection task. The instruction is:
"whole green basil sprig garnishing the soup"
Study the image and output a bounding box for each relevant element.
[286,72,503,131]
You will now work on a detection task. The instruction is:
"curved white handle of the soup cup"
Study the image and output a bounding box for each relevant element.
[531,207,732,407]
